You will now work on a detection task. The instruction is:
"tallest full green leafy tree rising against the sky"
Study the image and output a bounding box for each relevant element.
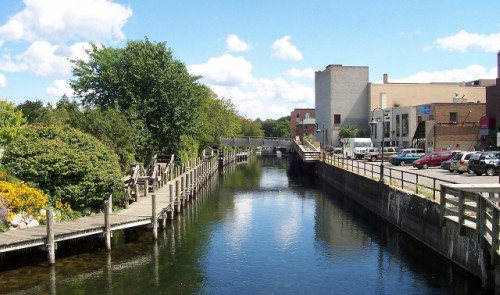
[70,38,206,157]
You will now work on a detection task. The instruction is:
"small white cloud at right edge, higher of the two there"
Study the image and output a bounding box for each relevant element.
[436,30,500,52]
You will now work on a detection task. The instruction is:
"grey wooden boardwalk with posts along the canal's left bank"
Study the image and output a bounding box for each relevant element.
[0,158,218,263]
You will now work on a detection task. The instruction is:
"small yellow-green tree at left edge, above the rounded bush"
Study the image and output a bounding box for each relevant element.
[0,99,26,145]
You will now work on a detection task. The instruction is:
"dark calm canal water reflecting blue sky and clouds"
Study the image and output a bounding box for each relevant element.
[0,158,486,295]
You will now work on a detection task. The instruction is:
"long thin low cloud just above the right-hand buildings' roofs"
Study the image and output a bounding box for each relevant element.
[390,65,497,83]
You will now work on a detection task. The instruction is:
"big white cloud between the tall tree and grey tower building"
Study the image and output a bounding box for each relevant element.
[188,54,314,119]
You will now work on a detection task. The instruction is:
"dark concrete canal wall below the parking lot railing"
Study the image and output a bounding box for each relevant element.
[316,162,488,280]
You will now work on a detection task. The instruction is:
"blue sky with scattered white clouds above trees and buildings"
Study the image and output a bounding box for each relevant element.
[0,0,500,120]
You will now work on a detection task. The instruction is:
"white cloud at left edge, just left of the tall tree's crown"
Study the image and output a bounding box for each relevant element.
[0,41,90,77]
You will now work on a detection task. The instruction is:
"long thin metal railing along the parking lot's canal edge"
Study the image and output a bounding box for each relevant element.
[324,155,456,200]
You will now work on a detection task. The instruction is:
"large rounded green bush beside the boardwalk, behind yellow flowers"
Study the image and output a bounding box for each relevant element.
[2,125,122,210]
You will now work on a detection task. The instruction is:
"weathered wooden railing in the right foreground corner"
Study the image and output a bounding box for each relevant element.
[440,184,500,265]
